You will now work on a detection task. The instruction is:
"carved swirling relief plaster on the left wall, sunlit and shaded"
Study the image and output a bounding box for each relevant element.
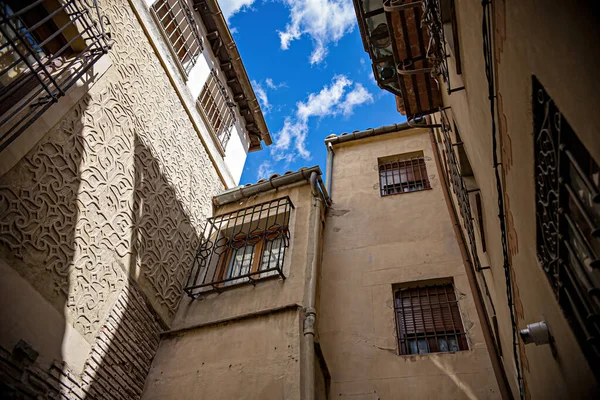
[0,0,223,341]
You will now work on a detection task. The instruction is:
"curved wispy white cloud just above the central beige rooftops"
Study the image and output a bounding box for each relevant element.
[271,75,373,168]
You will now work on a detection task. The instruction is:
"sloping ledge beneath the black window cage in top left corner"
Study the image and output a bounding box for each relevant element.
[0,54,112,176]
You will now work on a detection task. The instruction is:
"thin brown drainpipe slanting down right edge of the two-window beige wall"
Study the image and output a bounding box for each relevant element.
[429,130,513,400]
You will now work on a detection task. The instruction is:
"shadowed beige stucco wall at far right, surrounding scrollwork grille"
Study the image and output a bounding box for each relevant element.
[444,0,600,399]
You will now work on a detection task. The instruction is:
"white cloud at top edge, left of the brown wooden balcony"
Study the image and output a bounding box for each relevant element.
[279,0,356,64]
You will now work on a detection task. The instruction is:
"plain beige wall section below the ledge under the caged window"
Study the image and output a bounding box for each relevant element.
[143,310,301,400]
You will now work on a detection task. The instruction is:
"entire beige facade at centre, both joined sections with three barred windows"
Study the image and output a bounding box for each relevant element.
[143,129,501,400]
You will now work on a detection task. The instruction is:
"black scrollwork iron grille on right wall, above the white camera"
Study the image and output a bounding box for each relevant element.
[533,77,600,375]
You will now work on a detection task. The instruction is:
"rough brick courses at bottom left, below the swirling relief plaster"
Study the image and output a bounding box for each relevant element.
[0,282,161,400]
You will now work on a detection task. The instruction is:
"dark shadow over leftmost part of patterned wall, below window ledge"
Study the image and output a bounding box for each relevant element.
[0,96,89,398]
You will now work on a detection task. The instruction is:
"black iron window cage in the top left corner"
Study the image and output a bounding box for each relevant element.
[0,0,111,151]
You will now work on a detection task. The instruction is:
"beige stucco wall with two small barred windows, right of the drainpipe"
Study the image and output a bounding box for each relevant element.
[318,130,499,399]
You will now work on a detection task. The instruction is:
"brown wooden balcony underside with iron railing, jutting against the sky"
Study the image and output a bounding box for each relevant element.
[354,0,462,120]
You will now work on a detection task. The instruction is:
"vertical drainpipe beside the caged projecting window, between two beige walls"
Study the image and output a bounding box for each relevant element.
[300,172,323,400]
